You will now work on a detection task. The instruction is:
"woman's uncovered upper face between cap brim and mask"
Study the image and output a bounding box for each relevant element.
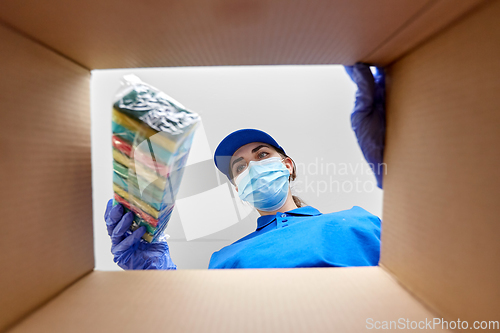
[229,142,293,191]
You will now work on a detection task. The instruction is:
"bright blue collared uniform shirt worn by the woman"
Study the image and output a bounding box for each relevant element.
[208,206,381,268]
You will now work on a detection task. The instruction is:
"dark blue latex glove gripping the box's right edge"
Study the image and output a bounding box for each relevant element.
[344,63,385,188]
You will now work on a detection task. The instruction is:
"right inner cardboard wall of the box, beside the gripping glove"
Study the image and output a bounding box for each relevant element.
[381,1,500,320]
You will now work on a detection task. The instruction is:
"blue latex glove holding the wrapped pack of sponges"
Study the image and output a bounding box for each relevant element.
[104,199,177,269]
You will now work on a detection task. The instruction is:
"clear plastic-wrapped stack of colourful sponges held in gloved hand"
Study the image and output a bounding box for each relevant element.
[112,75,200,242]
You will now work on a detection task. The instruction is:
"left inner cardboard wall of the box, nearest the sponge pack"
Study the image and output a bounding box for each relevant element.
[0,25,94,330]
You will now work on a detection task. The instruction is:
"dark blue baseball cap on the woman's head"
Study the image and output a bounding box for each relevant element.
[214,128,285,180]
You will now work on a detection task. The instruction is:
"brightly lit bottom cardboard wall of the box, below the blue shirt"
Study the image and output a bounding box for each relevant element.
[7,267,452,333]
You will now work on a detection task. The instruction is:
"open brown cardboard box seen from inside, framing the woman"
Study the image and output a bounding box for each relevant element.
[0,0,500,332]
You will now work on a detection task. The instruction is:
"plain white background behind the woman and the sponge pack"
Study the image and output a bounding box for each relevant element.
[91,65,383,270]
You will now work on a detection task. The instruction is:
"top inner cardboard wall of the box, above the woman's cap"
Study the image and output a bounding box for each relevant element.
[0,0,480,69]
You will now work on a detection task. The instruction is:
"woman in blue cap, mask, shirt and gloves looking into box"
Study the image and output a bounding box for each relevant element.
[105,64,385,269]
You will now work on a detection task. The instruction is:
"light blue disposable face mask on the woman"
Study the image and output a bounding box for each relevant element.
[235,157,290,212]
